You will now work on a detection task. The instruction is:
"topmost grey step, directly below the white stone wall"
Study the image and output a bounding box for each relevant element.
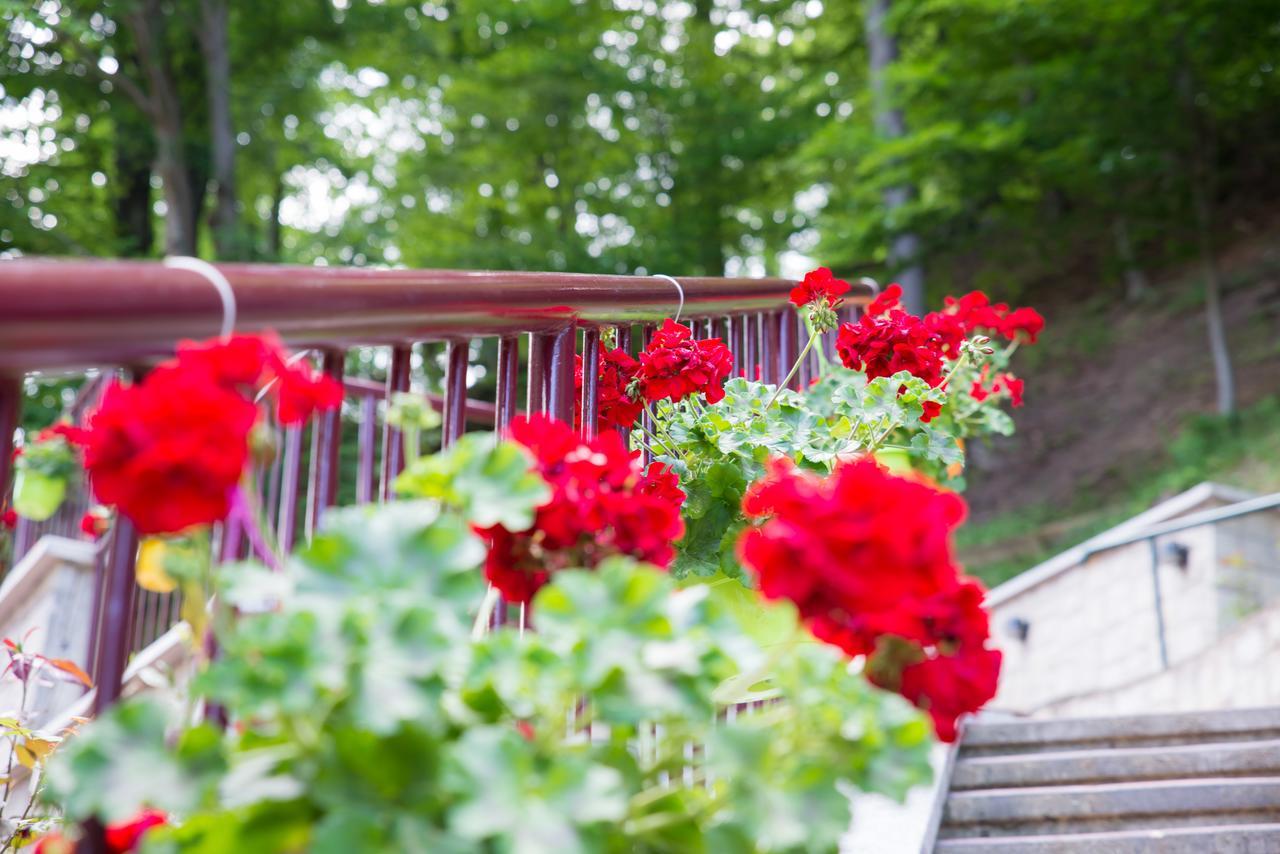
[960,708,1280,758]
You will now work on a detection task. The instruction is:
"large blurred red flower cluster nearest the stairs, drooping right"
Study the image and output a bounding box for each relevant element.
[739,460,1000,740]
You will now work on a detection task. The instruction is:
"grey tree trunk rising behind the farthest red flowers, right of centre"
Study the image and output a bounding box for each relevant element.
[865,0,924,315]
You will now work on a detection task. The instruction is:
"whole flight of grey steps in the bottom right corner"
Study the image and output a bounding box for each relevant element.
[925,708,1280,854]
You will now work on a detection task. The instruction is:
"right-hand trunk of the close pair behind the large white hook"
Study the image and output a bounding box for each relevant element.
[197,0,246,260]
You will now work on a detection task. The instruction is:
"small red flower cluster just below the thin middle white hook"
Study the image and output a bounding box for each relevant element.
[636,318,733,403]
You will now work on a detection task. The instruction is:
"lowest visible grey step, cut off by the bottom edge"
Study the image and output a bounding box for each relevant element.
[933,825,1280,854]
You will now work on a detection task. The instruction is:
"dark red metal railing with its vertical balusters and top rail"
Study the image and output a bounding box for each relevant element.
[0,259,874,711]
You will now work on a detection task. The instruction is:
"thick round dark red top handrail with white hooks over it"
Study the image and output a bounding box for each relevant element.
[0,259,849,373]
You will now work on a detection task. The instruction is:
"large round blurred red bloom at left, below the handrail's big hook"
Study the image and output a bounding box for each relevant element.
[82,364,257,534]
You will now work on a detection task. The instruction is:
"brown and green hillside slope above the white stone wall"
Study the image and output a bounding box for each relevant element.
[960,220,1280,584]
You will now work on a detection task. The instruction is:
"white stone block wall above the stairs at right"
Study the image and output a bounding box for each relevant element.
[989,485,1280,714]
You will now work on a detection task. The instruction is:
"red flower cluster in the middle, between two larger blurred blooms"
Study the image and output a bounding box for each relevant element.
[480,415,685,602]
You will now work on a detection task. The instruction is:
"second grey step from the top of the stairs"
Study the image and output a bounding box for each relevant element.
[951,739,1280,791]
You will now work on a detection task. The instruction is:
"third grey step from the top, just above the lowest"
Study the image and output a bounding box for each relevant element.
[938,777,1280,839]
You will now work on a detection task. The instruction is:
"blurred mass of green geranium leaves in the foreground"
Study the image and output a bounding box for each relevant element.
[49,438,929,854]
